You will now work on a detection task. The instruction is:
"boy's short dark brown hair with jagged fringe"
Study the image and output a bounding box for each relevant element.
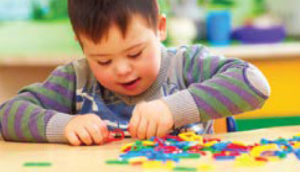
[68,0,159,43]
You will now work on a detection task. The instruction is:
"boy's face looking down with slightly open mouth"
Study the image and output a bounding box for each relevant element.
[80,15,166,96]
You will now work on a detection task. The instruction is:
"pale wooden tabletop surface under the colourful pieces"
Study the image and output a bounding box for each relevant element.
[0,126,300,172]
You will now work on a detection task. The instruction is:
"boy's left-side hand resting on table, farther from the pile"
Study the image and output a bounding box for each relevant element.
[64,114,108,146]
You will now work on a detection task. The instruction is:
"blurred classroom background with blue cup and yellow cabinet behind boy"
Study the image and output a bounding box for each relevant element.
[0,0,300,131]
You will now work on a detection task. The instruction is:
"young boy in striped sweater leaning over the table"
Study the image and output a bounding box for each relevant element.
[0,0,270,145]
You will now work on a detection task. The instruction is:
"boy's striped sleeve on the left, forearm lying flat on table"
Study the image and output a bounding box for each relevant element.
[0,64,76,142]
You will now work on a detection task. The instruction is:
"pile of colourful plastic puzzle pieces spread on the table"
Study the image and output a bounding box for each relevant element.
[106,132,300,171]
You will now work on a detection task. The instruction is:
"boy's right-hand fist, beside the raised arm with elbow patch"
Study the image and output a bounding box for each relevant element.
[129,100,174,139]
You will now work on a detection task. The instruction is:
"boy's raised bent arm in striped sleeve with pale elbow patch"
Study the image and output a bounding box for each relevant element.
[164,45,270,127]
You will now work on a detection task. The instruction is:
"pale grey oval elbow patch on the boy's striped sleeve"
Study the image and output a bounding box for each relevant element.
[245,65,271,99]
